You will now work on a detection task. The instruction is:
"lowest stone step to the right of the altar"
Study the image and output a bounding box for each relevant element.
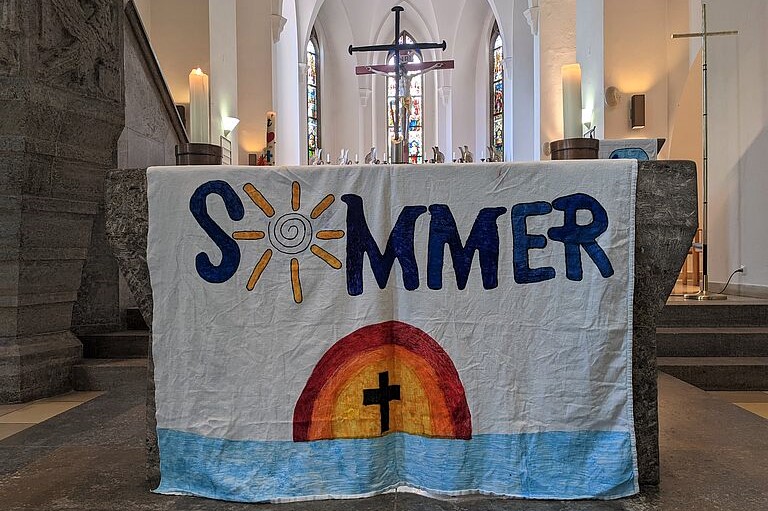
[658,357,768,390]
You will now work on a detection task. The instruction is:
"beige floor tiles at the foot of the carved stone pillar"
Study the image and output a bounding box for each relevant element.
[0,392,103,440]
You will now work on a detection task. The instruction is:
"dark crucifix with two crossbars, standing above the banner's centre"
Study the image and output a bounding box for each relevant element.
[349,6,453,163]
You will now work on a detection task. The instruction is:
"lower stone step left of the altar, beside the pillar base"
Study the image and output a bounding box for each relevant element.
[72,358,147,392]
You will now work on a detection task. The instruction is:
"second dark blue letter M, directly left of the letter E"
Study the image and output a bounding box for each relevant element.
[427,204,507,289]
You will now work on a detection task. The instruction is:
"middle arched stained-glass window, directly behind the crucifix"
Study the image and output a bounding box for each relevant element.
[387,30,424,163]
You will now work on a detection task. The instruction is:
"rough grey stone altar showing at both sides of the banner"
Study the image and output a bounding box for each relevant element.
[106,161,698,487]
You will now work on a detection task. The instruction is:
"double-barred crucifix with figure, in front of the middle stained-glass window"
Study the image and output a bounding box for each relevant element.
[349,6,453,159]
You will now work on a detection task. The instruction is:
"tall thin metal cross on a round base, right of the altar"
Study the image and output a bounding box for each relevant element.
[672,2,739,300]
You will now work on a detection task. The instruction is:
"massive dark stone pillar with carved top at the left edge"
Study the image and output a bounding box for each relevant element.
[0,0,124,403]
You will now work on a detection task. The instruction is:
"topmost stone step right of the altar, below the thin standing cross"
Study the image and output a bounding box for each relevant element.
[657,304,768,327]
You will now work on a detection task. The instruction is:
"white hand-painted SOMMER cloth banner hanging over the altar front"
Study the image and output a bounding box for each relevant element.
[148,160,638,502]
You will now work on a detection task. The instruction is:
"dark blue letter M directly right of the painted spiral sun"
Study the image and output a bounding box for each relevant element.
[341,194,427,296]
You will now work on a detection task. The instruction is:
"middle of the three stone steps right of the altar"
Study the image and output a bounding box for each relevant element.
[656,327,768,357]
